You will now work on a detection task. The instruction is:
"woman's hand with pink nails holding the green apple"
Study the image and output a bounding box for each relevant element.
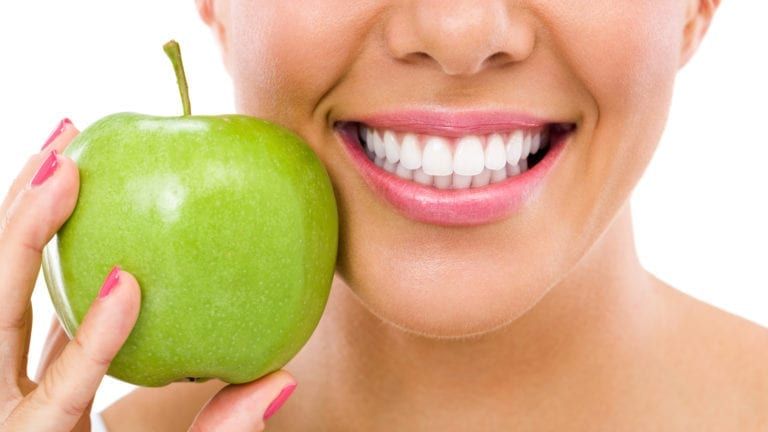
[0,121,295,432]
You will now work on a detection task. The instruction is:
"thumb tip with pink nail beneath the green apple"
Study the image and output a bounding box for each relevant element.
[190,370,296,432]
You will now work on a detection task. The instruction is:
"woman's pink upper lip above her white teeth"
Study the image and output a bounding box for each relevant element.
[342,110,569,138]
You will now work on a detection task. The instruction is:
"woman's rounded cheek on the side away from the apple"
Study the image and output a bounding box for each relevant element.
[546,0,683,116]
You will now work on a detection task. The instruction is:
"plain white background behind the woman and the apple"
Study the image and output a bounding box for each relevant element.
[0,0,768,416]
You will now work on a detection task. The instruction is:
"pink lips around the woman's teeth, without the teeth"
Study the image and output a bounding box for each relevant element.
[337,114,571,230]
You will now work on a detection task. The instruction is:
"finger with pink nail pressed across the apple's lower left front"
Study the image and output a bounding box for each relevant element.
[8,268,141,431]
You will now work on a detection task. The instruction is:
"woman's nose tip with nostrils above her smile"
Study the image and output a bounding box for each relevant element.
[386,0,535,76]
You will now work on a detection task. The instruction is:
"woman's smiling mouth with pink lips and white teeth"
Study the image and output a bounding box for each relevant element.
[333,109,578,226]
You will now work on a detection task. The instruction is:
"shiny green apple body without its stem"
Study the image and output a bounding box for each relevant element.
[43,113,338,386]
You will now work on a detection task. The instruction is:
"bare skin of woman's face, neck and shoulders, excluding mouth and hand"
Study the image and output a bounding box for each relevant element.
[0,0,768,431]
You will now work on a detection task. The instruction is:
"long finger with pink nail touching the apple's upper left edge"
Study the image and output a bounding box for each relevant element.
[0,152,79,380]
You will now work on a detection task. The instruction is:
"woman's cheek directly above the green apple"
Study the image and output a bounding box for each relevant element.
[228,0,378,128]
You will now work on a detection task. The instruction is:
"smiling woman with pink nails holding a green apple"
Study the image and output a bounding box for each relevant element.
[0,0,768,431]
